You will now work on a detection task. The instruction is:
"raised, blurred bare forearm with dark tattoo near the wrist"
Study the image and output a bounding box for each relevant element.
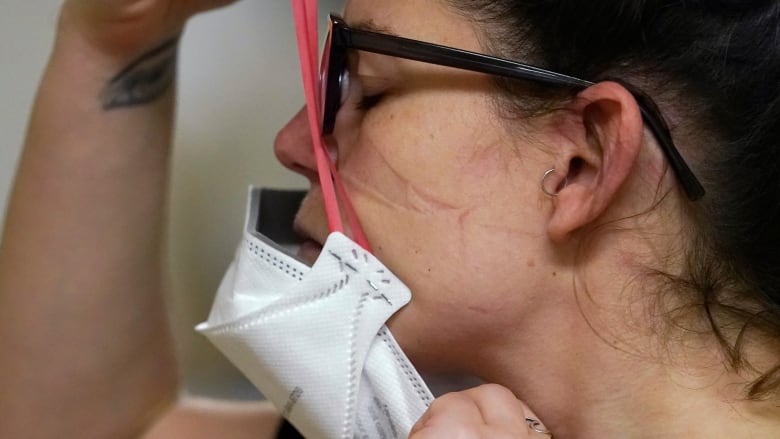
[0,15,176,438]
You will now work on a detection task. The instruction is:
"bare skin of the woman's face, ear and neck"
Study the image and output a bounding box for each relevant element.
[276,0,780,438]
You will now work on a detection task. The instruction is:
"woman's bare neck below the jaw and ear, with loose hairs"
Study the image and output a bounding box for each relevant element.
[475,260,780,439]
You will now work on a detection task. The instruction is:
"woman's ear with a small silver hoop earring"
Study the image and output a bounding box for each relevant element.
[547,82,644,242]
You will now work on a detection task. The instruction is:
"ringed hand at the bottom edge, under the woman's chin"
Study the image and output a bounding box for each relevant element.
[409,384,552,439]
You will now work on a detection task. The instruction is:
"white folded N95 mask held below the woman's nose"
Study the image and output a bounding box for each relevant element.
[197,189,433,439]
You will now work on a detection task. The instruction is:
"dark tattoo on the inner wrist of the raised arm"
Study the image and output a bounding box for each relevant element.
[100,37,179,110]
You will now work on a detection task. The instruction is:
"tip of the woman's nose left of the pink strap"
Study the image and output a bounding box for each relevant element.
[274,107,317,183]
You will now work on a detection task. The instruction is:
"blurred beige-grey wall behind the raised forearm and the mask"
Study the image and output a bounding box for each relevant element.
[0,0,343,397]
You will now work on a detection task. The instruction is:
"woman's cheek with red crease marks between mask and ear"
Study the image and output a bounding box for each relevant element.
[339,86,539,342]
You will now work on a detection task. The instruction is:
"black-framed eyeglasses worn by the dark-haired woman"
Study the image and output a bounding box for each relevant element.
[320,14,704,201]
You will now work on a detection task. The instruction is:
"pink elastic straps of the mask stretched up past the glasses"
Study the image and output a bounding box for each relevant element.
[292,0,370,251]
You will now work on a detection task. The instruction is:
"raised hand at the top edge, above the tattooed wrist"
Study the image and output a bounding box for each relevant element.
[60,0,236,57]
